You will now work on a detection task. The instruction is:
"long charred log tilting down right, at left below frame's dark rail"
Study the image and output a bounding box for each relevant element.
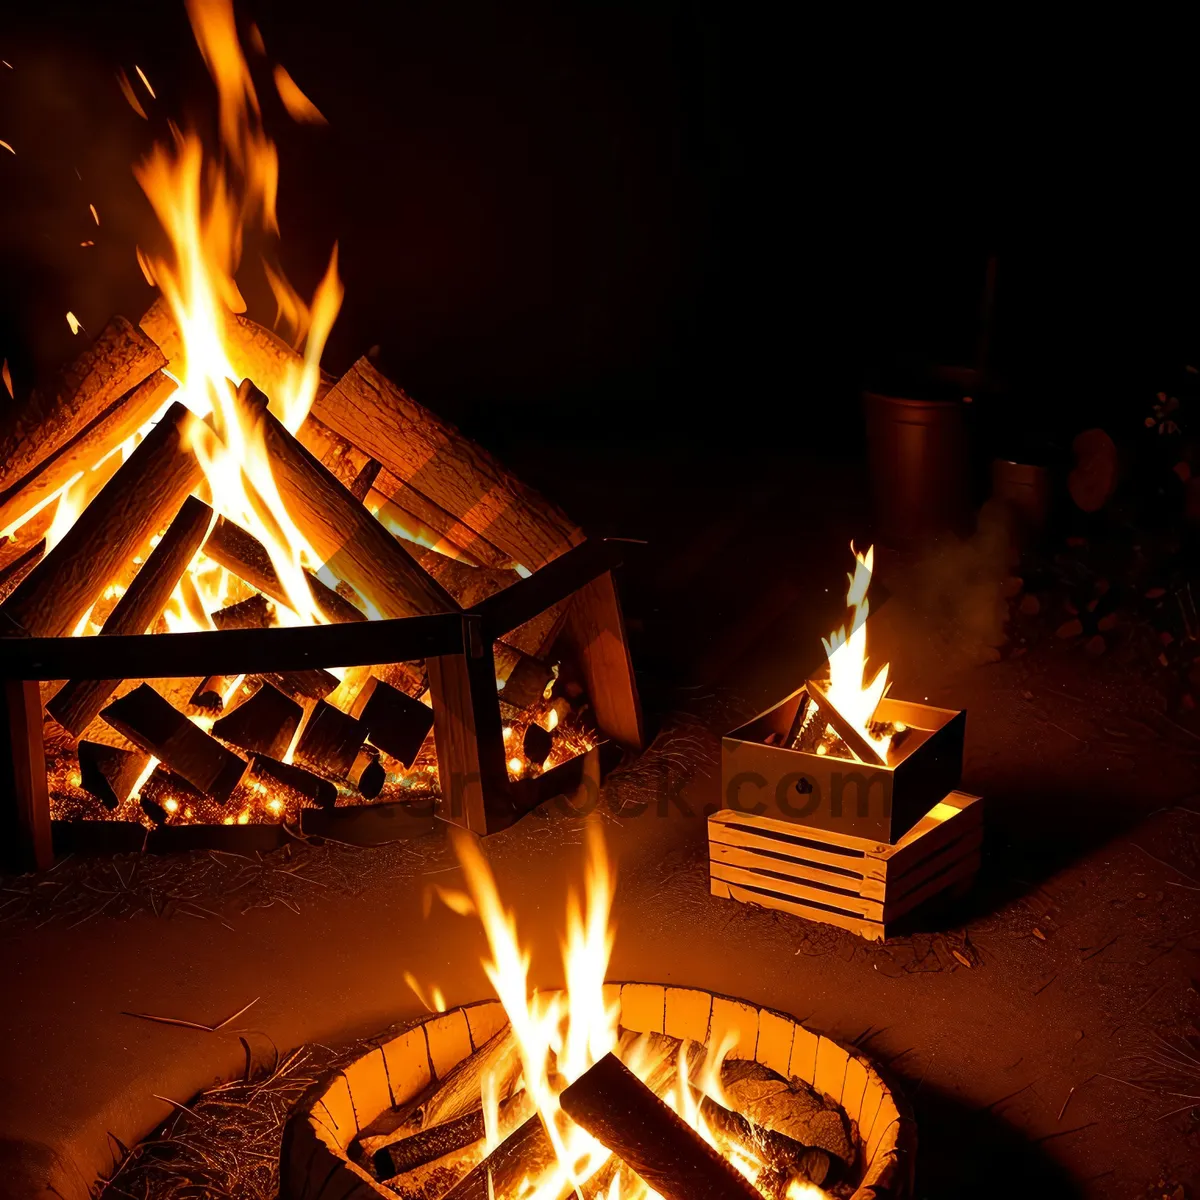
[100,683,247,804]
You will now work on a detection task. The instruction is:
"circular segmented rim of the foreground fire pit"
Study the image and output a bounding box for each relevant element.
[280,983,917,1200]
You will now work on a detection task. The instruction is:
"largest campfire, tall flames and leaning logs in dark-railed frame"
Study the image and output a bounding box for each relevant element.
[0,0,641,865]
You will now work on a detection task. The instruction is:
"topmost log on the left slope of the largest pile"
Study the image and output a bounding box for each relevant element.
[0,317,167,496]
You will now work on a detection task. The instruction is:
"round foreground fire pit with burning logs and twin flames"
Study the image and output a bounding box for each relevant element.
[282,826,911,1200]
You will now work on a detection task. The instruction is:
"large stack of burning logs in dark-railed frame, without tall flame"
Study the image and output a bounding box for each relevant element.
[0,300,636,844]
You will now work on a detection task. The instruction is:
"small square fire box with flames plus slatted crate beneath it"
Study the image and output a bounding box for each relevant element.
[709,551,982,938]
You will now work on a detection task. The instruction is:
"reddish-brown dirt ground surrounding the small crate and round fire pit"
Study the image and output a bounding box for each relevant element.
[0,455,1200,1200]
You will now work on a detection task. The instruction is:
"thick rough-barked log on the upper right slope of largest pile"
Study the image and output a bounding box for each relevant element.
[312,359,583,570]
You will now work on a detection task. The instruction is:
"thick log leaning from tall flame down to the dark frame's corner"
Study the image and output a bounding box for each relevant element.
[234,388,456,617]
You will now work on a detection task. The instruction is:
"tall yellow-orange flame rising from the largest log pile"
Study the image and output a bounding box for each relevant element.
[134,0,342,628]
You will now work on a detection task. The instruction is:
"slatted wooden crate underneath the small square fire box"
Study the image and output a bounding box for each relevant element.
[708,792,983,941]
